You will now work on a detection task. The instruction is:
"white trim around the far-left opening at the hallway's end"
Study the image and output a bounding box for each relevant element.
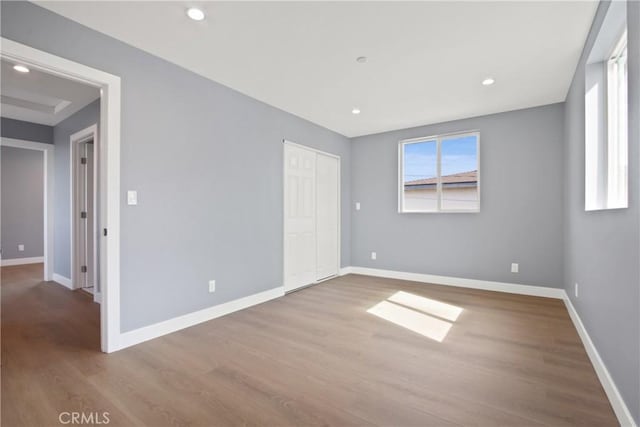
[0,138,55,281]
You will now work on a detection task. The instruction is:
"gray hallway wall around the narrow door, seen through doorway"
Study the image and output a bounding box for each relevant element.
[53,99,100,278]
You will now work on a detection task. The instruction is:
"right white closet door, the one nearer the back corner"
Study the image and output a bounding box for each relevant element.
[316,153,340,280]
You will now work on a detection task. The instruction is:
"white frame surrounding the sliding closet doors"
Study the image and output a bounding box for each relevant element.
[282,139,342,293]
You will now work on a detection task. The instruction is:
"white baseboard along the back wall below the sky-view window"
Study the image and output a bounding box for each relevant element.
[348,267,564,299]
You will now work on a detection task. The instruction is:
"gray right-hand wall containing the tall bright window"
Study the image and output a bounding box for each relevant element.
[564,1,640,423]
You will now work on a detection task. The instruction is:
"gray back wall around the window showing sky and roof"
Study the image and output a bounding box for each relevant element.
[351,104,563,287]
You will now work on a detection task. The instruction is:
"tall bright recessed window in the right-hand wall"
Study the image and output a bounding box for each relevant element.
[585,2,629,211]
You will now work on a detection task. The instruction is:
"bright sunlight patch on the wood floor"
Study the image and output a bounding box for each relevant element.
[367,291,462,342]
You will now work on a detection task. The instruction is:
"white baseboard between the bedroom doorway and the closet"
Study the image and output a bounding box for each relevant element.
[118,287,284,349]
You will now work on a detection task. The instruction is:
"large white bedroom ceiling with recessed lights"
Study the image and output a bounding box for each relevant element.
[37,1,597,136]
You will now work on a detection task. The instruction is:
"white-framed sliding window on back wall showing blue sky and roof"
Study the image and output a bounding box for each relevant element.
[398,132,480,212]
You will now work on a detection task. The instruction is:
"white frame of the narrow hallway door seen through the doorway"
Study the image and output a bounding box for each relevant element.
[69,123,102,303]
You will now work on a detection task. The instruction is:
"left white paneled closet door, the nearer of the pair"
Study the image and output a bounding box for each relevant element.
[284,144,316,291]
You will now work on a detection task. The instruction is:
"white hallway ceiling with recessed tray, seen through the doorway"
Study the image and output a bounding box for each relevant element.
[0,60,100,126]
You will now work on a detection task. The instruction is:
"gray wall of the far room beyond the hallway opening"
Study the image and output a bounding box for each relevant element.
[0,147,44,259]
